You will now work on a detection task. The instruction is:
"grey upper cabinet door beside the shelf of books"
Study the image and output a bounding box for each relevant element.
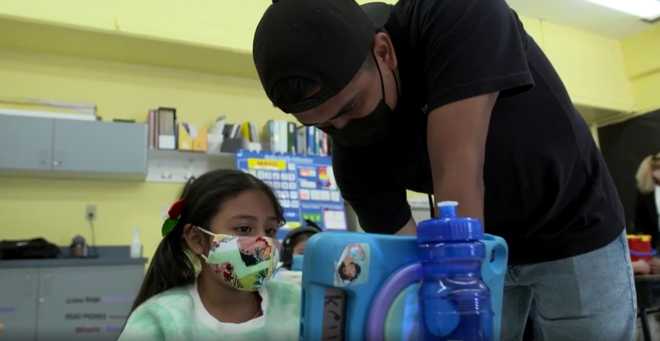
[53,120,147,178]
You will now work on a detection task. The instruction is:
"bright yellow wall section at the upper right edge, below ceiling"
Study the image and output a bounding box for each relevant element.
[622,24,660,113]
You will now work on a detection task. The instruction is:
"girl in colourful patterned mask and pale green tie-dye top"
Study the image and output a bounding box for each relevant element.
[119,170,301,341]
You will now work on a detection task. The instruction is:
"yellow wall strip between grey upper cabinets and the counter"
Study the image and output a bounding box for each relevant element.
[0,177,175,258]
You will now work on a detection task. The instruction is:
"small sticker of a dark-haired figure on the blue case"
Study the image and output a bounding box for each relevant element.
[335,243,369,287]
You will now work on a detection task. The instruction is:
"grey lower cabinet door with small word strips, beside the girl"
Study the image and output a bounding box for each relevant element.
[37,265,144,341]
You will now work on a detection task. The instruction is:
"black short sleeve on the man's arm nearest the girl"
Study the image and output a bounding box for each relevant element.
[332,148,412,234]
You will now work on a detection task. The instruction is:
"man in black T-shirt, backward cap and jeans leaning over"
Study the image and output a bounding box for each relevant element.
[253,0,635,340]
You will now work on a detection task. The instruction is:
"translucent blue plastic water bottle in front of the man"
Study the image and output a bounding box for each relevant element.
[417,201,493,341]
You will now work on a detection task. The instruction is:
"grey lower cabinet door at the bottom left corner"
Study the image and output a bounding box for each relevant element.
[0,269,39,341]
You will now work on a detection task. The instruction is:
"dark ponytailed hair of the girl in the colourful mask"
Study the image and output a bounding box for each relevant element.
[131,169,284,312]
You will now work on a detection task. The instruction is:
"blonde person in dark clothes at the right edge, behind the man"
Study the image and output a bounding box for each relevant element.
[633,153,660,274]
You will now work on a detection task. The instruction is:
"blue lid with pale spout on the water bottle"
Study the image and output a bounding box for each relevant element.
[417,201,484,244]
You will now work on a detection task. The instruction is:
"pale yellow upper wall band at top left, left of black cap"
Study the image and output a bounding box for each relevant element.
[0,0,271,52]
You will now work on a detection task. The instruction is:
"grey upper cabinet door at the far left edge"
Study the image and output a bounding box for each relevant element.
[0,115,53,171]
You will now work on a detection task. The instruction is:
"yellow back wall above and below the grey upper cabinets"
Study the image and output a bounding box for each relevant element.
[0,49,287,256]
